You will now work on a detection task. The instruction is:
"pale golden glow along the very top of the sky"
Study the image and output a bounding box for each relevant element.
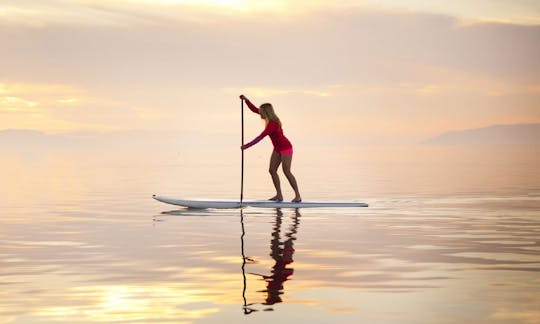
[0,0,540,24]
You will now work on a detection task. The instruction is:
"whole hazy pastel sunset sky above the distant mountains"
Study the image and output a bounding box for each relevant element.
[0,0,540,140]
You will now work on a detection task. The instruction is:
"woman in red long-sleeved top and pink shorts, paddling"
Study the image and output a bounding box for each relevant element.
[240,95,302,202]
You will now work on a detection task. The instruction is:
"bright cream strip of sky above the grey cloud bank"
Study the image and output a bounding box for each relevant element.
[0,0,540,26]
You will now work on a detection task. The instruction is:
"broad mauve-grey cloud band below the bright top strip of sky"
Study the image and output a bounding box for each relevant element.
[0,12,540,87]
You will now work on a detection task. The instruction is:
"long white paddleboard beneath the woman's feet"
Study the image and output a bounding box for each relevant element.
[152,195,368,208]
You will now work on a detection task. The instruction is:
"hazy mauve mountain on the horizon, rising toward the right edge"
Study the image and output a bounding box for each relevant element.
[426,124,540,145]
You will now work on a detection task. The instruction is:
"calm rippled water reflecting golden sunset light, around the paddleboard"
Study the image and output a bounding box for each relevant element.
[0,146,540,323]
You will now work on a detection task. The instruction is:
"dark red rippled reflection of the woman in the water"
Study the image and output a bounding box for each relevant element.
[253,209,300,305]
